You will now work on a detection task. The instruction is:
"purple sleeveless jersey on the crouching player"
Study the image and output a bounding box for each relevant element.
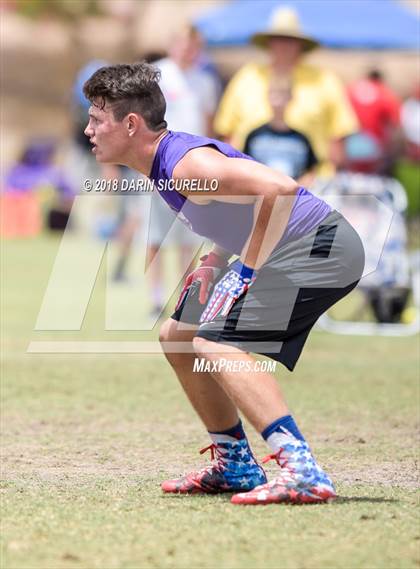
[150,131,331,255]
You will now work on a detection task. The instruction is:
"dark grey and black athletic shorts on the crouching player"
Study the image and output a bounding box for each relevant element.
[172,211,365,371]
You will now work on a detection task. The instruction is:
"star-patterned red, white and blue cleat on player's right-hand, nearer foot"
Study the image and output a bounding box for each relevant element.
[232,439,337,505]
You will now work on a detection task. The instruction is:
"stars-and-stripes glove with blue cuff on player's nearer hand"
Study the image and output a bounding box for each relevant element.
[200,260,257,324]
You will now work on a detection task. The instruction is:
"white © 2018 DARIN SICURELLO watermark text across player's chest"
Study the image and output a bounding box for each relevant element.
[83,178,219,194]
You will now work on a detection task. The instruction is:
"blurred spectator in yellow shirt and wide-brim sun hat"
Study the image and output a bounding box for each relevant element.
[215,8,357,175]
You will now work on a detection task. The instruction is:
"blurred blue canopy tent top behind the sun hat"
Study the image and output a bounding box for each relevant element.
[195,0,420,50]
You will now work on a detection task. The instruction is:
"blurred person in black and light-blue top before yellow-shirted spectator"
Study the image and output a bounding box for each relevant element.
[244,78,318,186]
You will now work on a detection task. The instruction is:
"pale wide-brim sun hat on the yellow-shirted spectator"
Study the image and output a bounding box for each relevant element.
[251,7,319,51]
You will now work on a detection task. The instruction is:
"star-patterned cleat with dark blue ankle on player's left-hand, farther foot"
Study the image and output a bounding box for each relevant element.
[161,439,267,494]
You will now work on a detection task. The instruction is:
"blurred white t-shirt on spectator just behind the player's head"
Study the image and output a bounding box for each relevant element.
[155,58,218,136]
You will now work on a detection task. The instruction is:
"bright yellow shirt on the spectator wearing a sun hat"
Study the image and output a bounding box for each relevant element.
[214,63,358,175]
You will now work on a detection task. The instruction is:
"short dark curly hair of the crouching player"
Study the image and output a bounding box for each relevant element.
[83,61,167,131]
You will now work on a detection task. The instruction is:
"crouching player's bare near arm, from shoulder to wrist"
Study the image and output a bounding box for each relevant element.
[173,147,298,270]
